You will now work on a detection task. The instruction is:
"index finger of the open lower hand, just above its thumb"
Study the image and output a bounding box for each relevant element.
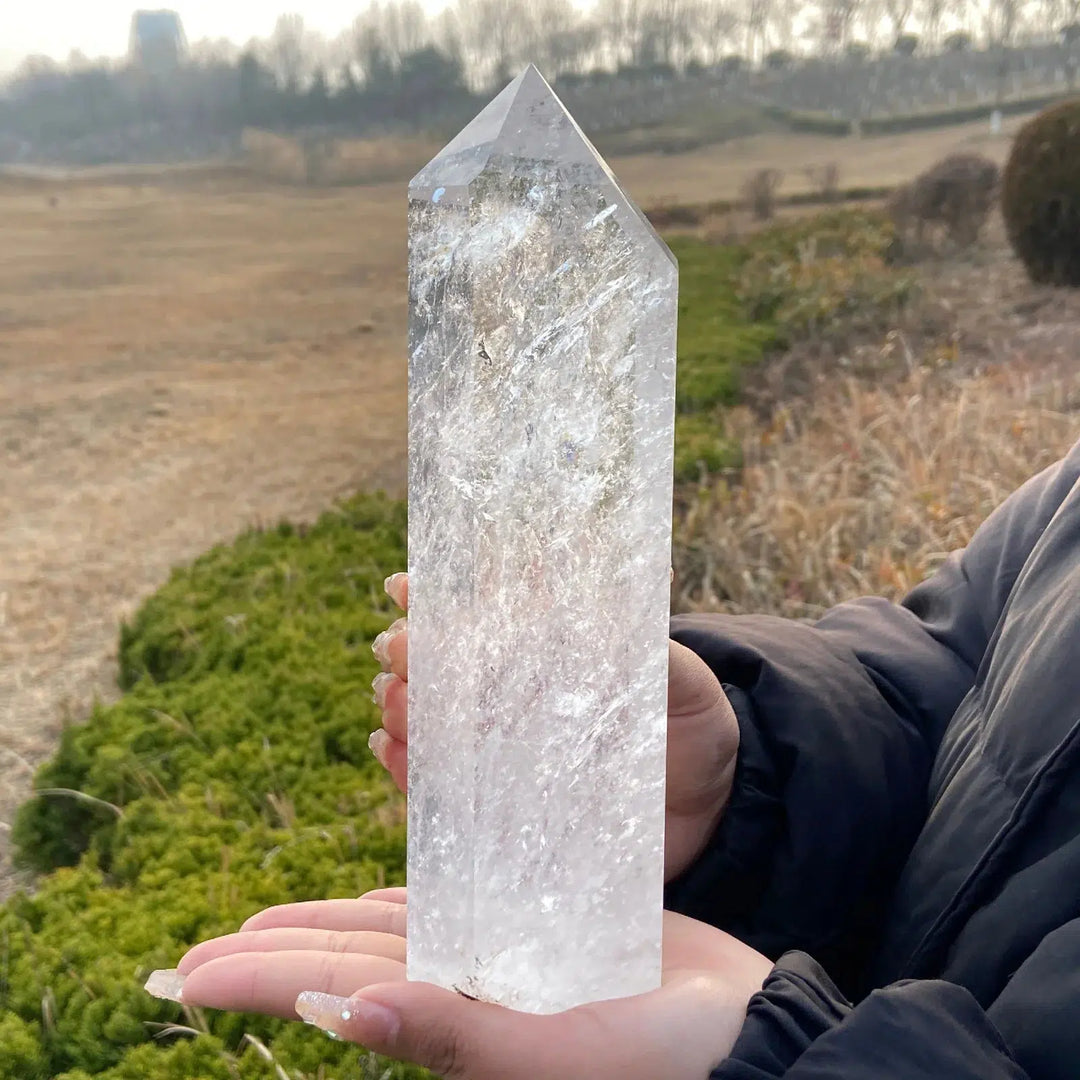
[180,949,405,1020]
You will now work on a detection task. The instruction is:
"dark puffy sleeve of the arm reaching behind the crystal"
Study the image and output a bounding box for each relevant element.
[666,444,1080,989]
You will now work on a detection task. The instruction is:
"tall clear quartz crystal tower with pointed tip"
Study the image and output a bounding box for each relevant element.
[408,67,678,1012]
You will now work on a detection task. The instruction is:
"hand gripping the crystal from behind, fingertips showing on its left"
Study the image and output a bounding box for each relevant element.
[369,573,739,881]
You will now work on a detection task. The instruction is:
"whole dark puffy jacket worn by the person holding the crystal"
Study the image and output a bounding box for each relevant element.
[667,434,1080,1080]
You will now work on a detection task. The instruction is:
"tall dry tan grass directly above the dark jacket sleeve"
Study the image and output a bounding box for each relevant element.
[673,362,1080,618]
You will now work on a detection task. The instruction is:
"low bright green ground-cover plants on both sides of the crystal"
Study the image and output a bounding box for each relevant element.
[0,206,911,1080]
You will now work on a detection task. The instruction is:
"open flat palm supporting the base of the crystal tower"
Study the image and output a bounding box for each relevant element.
[156,889,772,1080]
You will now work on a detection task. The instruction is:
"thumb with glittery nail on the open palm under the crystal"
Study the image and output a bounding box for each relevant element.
[296,982,568,1080]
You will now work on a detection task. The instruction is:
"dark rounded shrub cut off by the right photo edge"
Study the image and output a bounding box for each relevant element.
[1001,99,1080,287]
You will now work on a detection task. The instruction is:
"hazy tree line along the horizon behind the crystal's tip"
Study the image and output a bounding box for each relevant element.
[0,0,1080,150]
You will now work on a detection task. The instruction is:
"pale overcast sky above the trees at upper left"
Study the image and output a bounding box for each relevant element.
[0,0,445,69]
